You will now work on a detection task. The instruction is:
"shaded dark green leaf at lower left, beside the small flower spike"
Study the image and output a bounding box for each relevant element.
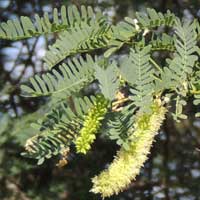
[23,96,96,164]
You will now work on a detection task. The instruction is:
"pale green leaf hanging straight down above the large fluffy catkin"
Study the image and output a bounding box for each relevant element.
[120,46,154,111]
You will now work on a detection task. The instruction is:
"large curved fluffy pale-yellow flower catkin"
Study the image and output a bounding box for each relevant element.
[91,104,166,198]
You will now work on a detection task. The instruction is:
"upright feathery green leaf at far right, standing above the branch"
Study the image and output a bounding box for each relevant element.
[160,19,198,90]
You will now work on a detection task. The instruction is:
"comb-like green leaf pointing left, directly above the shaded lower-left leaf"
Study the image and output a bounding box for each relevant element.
[21,55,97,99]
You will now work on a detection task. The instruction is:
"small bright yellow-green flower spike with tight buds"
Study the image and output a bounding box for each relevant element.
[75,95,108,154]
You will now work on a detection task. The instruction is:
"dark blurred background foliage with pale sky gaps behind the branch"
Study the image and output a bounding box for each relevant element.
[0,0,200,200]
